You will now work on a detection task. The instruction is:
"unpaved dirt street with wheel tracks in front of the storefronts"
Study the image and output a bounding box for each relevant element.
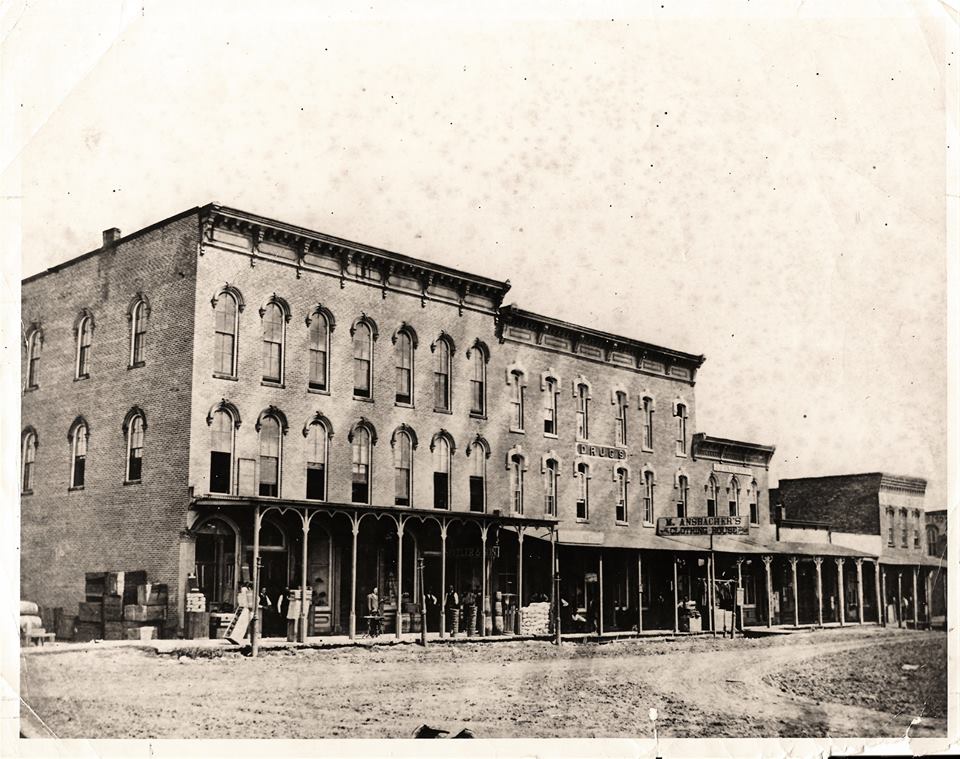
[21,627,946,738]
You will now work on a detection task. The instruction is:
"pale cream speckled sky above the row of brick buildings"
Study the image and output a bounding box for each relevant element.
[0,2,958,508]
